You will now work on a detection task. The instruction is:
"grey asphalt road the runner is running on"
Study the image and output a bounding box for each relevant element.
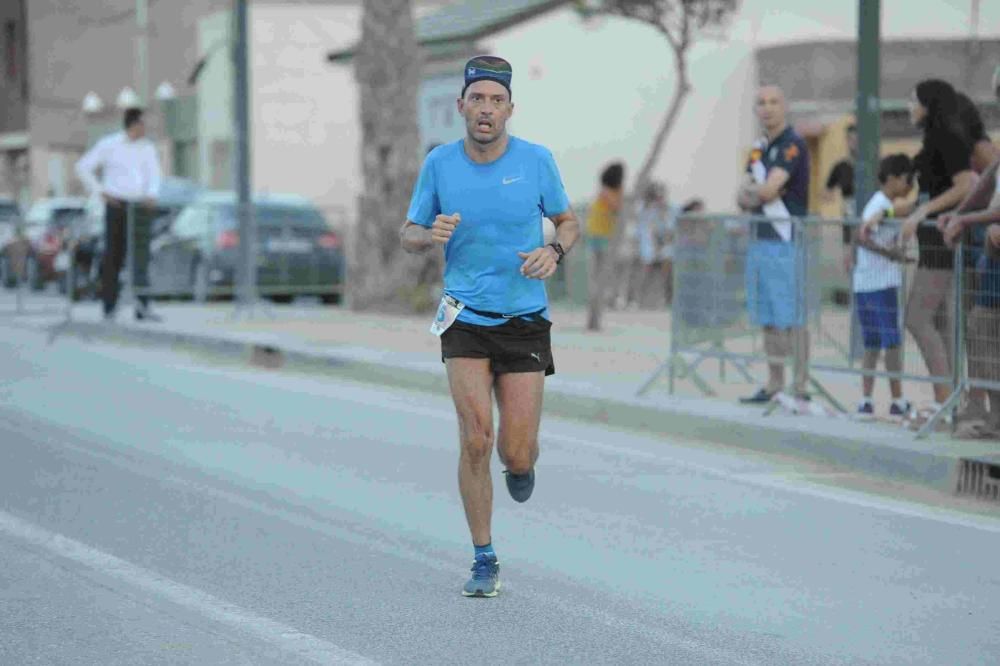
[0,325,1000,665]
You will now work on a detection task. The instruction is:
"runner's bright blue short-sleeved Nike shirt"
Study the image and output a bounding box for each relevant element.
[407,136,569,326]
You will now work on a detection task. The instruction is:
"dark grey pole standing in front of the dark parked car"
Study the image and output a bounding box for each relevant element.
[233,0,257,310]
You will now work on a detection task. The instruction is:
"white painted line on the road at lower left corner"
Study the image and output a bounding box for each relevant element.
[0,511,376,666]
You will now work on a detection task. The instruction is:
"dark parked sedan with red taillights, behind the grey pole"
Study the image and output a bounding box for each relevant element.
[149,192,344,303]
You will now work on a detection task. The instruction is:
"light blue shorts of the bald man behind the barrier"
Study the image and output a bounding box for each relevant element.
[746,240,805,328]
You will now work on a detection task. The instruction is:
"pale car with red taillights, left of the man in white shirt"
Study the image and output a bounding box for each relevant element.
[4,197,87,290]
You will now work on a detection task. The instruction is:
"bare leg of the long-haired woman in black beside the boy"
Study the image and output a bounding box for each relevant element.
[906,268,951,403]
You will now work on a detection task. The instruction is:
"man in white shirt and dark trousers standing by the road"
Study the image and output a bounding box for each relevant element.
[76,109,160,321]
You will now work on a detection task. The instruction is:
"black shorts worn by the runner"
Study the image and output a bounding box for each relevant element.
[441,315,556,376]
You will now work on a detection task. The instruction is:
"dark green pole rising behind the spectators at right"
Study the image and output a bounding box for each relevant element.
[854,0,882,217]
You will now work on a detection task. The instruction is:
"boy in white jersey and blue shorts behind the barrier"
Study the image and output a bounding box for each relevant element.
[852,154,913,416]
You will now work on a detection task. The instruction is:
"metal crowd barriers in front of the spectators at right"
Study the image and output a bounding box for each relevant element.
[638,215,1000,437]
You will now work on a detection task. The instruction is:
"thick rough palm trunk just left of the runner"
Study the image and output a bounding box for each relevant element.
[348,0,441,312]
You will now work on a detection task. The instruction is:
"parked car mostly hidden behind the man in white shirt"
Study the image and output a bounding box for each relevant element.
[73,177,204,300]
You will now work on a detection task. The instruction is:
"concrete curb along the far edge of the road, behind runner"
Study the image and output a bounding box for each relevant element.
[52,321,1000,493]
